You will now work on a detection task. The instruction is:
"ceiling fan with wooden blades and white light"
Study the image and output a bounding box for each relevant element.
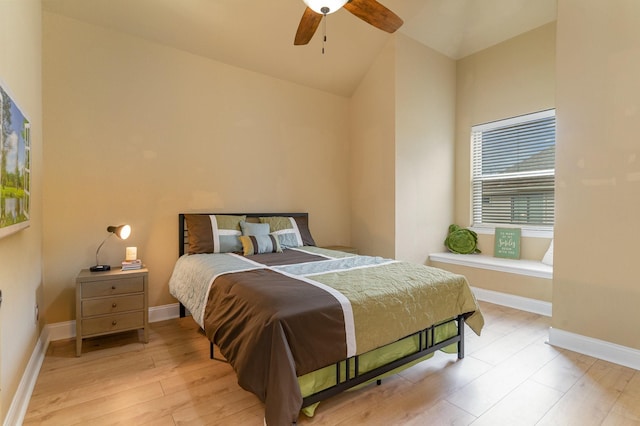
[293,0,404,46]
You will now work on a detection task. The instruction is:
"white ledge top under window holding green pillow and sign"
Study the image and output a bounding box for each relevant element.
[429,253,553,279]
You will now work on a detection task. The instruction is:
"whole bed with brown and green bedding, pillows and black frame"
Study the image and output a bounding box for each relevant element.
[169,213,484,426]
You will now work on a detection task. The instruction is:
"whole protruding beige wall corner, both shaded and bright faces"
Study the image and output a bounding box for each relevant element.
[350,34,455,263]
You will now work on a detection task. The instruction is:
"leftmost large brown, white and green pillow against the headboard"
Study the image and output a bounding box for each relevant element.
[184,214,247,254]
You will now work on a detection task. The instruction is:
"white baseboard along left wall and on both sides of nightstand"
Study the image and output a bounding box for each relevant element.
[3,303,180,426]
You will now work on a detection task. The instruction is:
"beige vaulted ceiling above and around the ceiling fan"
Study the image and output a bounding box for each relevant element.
[42,0,556,96]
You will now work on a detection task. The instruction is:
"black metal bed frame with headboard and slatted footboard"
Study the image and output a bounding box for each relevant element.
[178,213,464,414]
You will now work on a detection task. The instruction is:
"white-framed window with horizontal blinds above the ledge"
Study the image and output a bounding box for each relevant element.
[471,110,556,230]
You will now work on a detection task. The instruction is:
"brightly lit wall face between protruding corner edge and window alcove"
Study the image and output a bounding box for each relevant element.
[395,34,456,263]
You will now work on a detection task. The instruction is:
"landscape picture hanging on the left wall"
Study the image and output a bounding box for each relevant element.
[0,81,31,238]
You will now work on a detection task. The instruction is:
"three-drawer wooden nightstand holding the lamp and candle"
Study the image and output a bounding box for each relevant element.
[76,268,149,356]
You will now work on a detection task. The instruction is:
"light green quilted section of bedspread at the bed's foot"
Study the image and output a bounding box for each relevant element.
[283,247,484,354]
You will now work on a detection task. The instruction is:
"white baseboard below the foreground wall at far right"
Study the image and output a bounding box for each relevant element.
[549,327,640,370]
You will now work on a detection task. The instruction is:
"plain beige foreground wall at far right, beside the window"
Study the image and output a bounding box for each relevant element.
[553,0,640,349]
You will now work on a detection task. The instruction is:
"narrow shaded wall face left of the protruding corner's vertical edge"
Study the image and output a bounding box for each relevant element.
[349,39,396,257]
